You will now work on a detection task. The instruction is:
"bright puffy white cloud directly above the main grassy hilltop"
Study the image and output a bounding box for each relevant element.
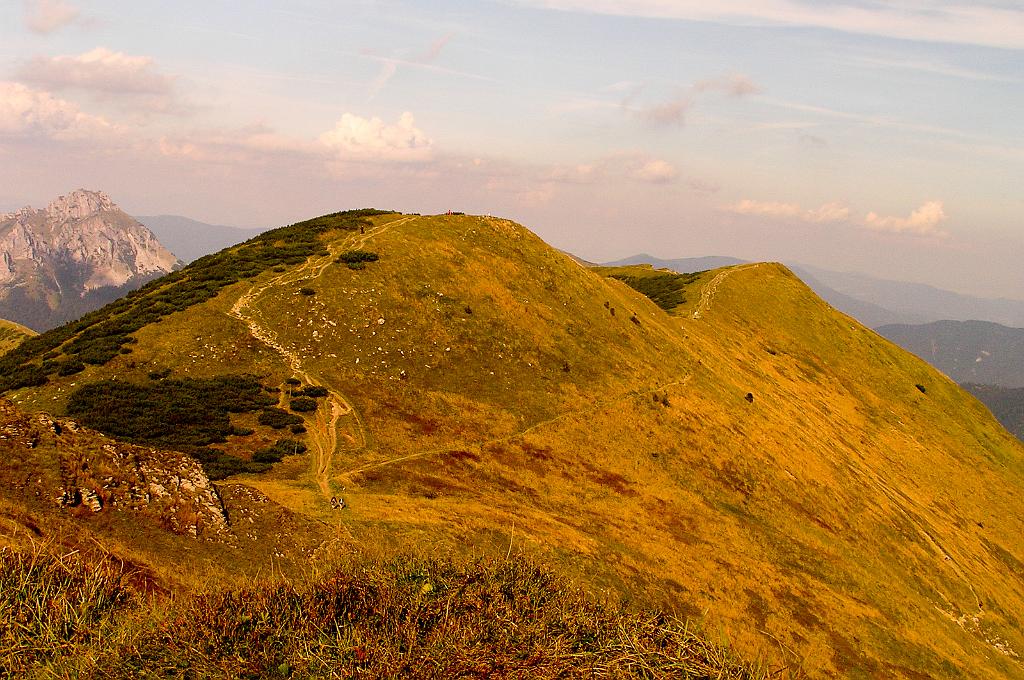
[319,112,433,162]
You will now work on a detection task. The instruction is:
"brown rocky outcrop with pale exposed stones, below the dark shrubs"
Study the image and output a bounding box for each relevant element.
[0,399,228,540]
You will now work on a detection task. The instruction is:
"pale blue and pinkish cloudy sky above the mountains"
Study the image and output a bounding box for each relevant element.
[0,0,1024,299]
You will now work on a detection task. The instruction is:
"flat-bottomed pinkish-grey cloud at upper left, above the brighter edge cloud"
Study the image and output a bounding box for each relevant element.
[18,47,173,95]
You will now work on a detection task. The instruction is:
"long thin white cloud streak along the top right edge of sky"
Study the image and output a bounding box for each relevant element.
[514,0,1024,49]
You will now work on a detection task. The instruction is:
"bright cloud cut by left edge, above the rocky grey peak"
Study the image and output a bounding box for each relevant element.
[0,81,113,140]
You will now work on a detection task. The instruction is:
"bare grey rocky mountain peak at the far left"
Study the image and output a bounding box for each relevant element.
[0,189,178,330]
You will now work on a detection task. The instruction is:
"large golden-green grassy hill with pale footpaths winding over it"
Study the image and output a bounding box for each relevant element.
[0,212,1024,677]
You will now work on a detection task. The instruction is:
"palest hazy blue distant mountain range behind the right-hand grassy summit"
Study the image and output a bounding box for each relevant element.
[607,254,1024,328]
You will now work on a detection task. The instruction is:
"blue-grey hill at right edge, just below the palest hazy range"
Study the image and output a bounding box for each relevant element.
[878,321,1024,387]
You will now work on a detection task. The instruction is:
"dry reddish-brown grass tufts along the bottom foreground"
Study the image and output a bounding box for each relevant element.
[0,550,768,679]
